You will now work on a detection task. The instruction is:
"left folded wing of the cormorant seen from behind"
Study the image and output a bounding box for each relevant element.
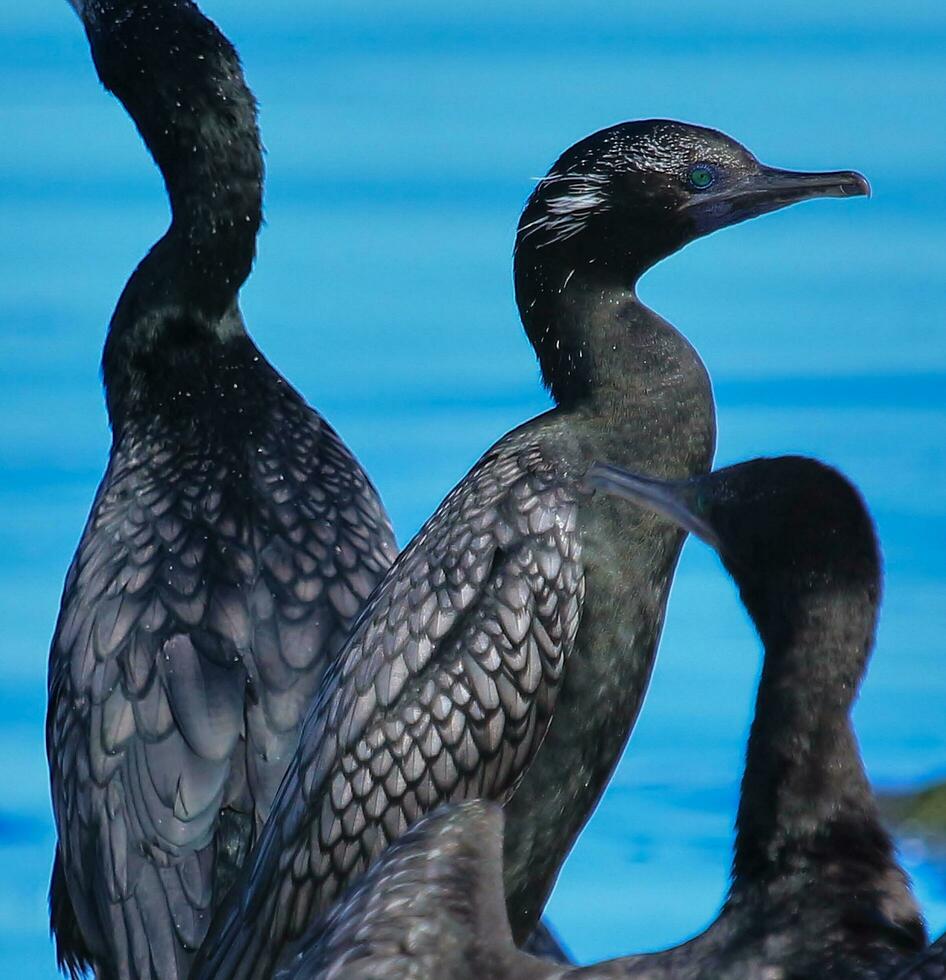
[47,457,246,977]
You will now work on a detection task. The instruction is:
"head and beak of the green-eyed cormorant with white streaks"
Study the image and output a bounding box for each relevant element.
[516,119,870,298]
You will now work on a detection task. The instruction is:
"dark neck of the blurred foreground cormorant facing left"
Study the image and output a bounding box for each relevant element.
[733,592,897,897]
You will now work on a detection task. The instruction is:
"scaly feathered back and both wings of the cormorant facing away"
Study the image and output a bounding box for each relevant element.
[47,392,394,980]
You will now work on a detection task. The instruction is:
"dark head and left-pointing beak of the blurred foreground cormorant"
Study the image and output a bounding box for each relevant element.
[588,456,881,665]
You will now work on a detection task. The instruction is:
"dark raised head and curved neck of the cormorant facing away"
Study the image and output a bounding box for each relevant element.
[75,0,263,421]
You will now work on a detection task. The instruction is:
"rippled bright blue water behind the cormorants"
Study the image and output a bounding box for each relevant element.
[0,0,946,964]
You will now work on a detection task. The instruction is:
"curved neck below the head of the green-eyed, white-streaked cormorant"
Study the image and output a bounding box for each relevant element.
[516,256,710,419]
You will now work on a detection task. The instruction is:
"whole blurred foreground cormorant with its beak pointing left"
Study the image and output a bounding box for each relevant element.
[276,457,928,980]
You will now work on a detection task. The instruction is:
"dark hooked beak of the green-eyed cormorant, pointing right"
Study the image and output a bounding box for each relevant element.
[682,165,870,233]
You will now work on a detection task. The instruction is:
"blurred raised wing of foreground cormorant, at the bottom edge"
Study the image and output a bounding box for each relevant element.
[274,801,515,980]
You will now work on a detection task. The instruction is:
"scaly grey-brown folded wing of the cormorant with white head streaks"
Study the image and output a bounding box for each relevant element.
[194,438,584,978]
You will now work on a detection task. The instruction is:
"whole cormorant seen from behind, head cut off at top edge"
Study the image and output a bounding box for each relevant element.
[47,0,395,980]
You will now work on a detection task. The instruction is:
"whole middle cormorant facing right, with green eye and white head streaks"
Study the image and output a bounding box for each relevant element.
[195,120,866,980]
